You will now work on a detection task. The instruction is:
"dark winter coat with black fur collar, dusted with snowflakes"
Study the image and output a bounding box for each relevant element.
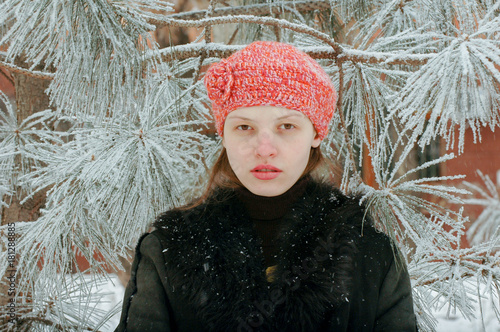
[116,182,416,332]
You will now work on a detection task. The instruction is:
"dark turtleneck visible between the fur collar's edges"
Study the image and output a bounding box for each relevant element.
[237,176,309,266]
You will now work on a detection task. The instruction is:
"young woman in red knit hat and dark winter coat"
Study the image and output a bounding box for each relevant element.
[117,42,416,331]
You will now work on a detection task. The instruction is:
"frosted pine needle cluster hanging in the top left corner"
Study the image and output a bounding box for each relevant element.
[0,0,172,118]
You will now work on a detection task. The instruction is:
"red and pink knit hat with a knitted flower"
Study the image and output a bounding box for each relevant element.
[204,41,337,139]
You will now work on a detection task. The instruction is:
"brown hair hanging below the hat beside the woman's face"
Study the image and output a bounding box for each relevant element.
[180,147,325,210]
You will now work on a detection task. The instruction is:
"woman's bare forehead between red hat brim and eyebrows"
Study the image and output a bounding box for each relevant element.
[226,105,308,121]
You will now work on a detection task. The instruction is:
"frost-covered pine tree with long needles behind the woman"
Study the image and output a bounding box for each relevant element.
[0,0,500,331]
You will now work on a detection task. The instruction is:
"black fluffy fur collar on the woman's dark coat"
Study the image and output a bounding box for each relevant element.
[155,182,364,331]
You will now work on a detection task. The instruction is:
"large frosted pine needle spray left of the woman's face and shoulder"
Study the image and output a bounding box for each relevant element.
[0,82,214,326]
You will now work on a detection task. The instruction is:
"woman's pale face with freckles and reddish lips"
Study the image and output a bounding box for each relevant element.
[222,106,321,197]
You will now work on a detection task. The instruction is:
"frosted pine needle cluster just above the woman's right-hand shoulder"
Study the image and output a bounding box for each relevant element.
[360,119,469,249]
